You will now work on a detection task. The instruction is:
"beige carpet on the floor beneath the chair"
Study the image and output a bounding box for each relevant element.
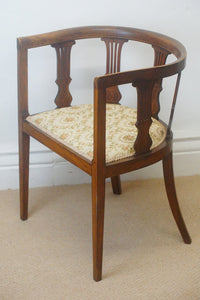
[0,176,200,300]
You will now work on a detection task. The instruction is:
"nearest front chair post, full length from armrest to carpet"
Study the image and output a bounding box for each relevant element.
[92,78,106,281]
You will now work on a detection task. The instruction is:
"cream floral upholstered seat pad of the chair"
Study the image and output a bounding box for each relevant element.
[27,104,166,162]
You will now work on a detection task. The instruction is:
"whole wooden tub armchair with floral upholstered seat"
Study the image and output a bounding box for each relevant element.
[17,26,191,281]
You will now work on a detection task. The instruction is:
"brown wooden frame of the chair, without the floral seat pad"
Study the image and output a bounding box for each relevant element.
[17,26,191,281]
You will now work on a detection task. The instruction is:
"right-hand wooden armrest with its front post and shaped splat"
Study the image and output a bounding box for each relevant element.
[94,60,185,157]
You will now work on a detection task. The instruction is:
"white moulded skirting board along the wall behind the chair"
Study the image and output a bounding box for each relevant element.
[0,137,200,190]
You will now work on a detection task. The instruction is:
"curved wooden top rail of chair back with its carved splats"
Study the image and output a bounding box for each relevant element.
[18,26,186,155]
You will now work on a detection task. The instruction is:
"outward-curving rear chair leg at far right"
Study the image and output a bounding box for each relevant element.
[163,152,192,244]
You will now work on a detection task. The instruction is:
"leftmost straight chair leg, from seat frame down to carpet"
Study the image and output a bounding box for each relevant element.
[19,132,30,220]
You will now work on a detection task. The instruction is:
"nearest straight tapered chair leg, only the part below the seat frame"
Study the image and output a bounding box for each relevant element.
[92,177,105,281]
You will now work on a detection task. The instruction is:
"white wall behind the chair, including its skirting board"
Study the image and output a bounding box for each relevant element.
[0,0,200,189]
